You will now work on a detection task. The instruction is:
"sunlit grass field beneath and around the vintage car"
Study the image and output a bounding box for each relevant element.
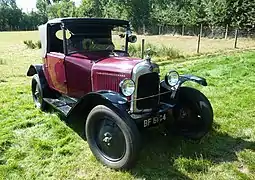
[0,32,255,180]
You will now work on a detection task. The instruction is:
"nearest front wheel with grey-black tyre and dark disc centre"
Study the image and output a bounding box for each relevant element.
[86,105,140,169]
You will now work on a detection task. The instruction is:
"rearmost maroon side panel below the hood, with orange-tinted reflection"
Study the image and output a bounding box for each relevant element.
[45,52,67,94]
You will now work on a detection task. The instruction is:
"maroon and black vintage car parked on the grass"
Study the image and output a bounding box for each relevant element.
[27,18,213,169]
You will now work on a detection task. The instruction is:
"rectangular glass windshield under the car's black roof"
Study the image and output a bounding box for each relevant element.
[66,26,126,54]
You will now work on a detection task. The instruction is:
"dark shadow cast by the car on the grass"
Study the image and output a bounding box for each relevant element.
[59,113,255,179]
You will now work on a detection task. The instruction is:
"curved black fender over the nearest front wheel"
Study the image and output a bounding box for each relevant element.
[67,91,130,129]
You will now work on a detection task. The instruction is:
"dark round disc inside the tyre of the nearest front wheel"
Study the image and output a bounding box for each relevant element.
[94,118,126,161]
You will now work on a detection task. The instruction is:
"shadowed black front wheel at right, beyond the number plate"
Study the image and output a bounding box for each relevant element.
[170,87,213,140]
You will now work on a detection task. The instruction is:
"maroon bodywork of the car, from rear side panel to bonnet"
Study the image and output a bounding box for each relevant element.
[44,52,142,98]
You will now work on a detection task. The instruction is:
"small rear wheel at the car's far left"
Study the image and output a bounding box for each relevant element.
[31,74,47,111]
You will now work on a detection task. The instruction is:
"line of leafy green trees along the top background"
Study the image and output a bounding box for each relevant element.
[0,0,255,32]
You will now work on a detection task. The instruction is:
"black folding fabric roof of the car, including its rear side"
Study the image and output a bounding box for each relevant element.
[38,17,130,58]
